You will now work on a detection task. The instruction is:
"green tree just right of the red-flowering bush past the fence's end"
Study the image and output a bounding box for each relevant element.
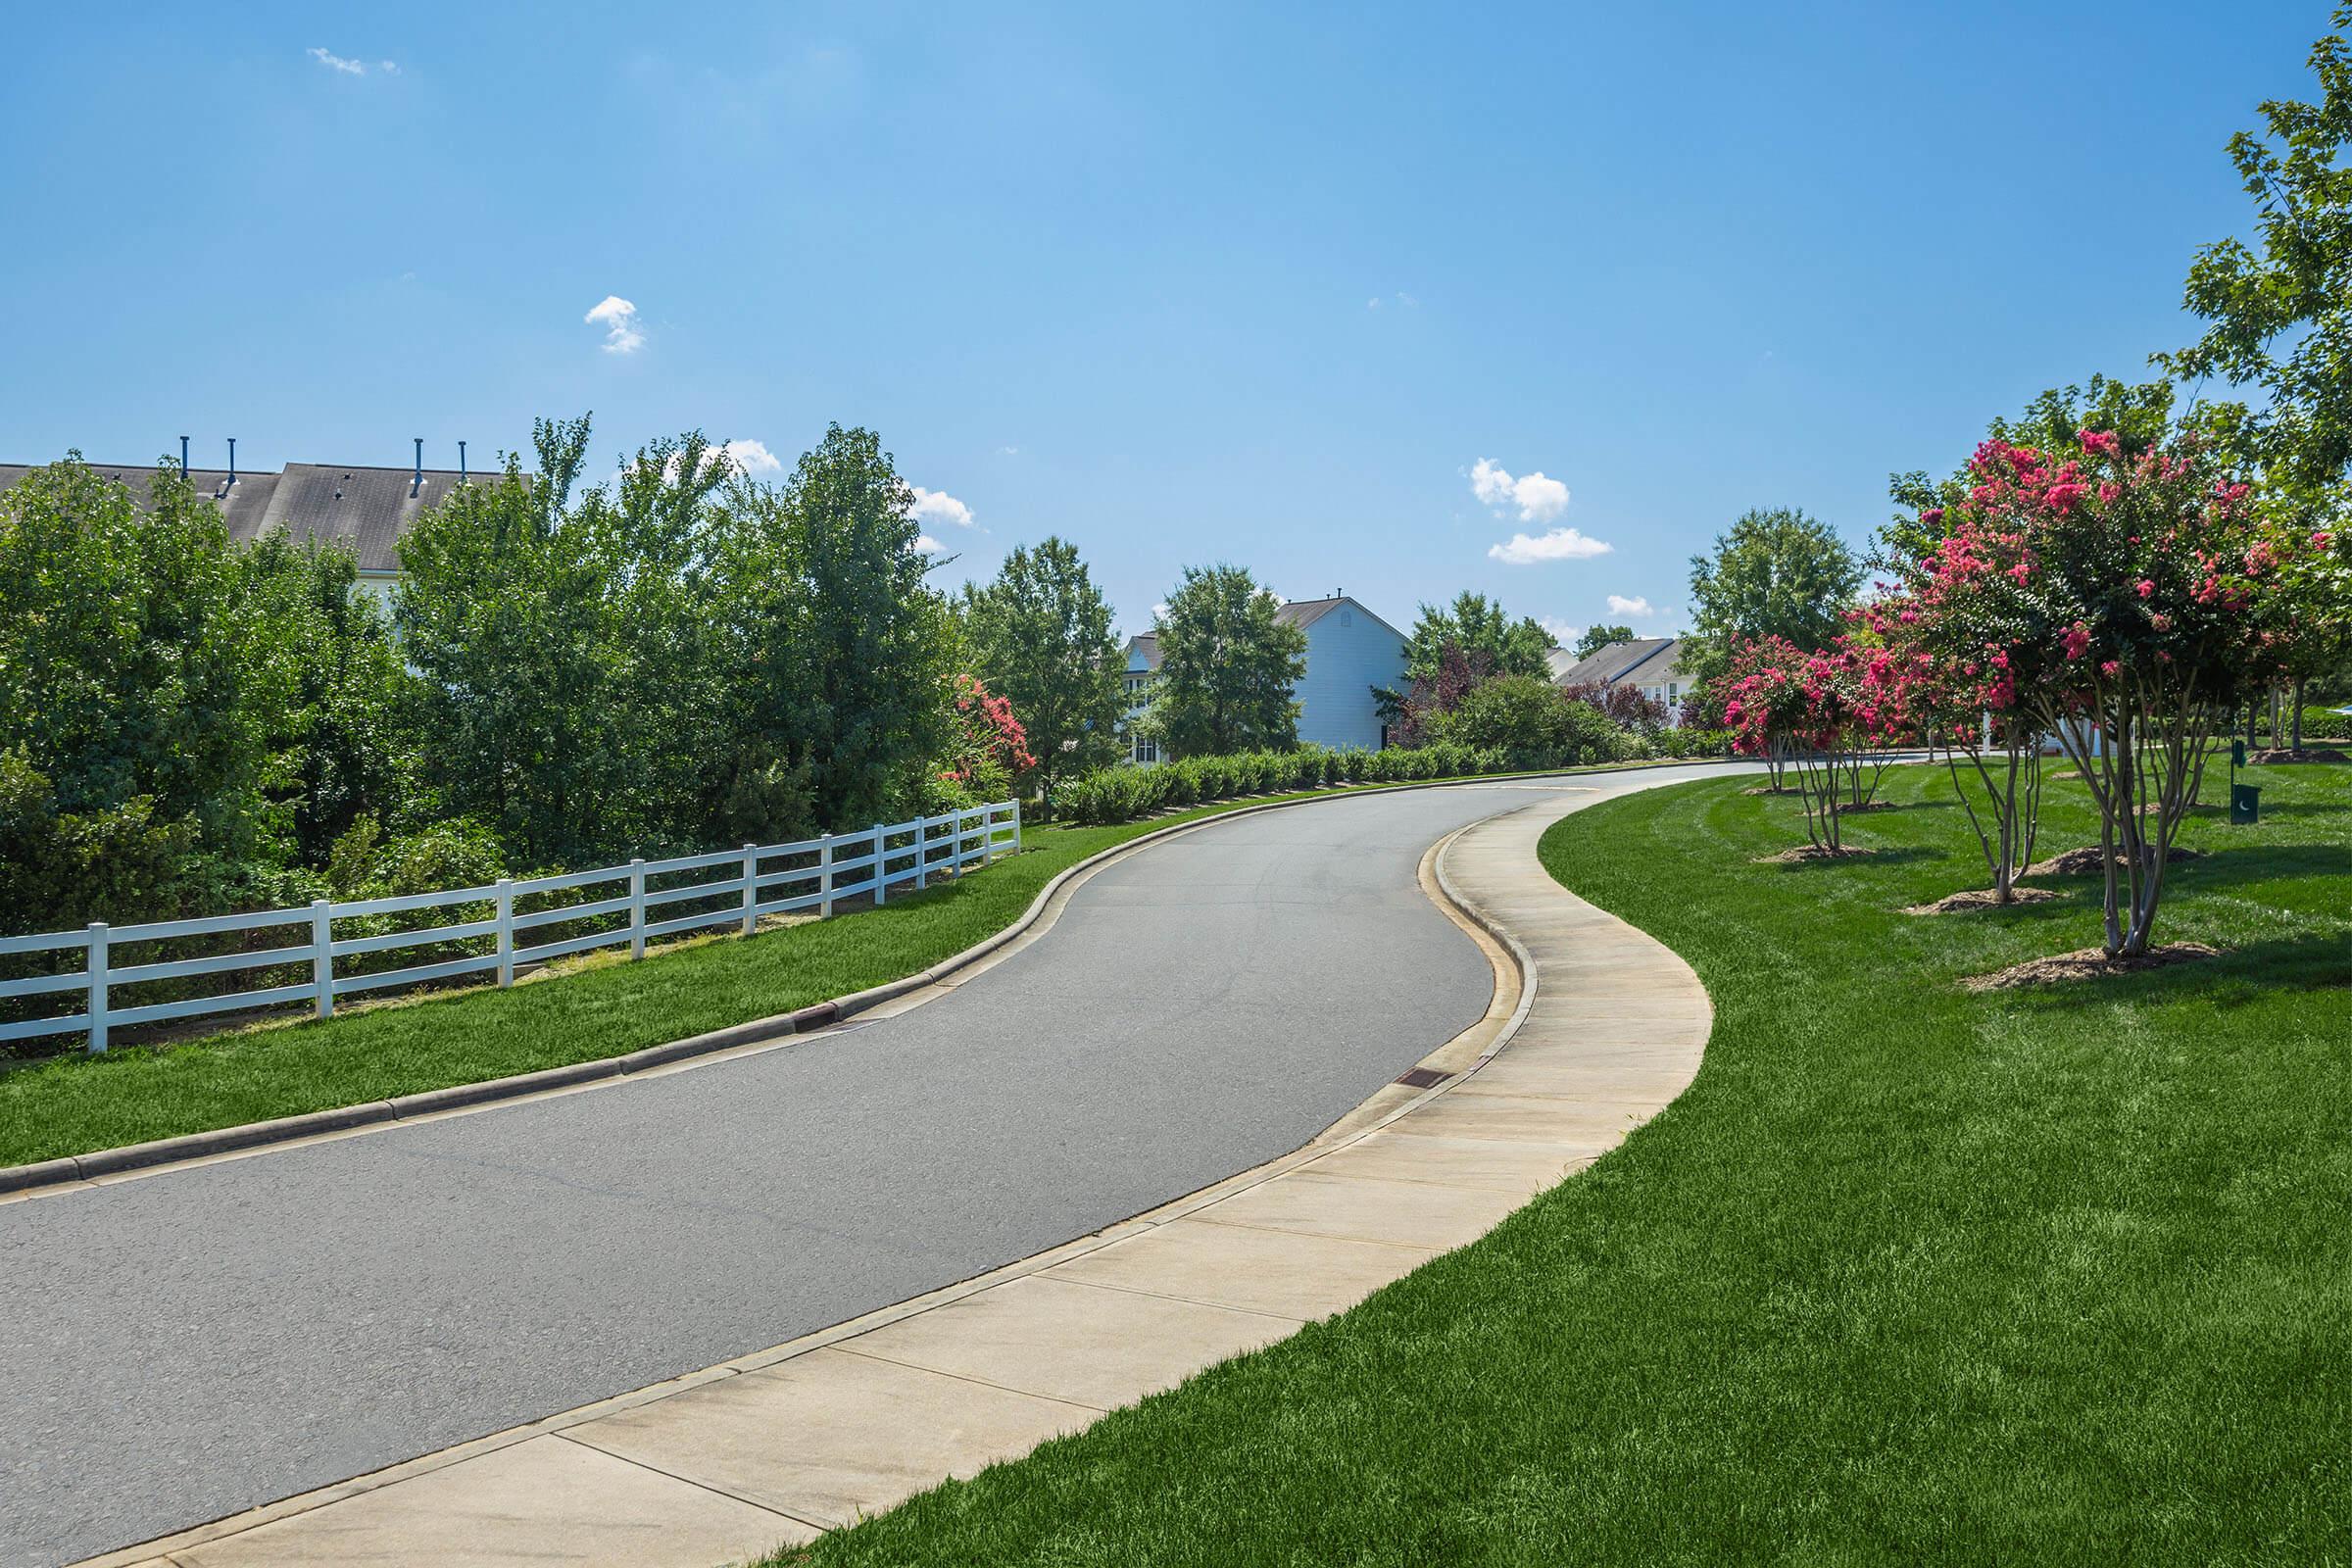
[962,536,1127,800]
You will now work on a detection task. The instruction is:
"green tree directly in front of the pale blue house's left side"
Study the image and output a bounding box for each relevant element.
[1146,566,1307,757]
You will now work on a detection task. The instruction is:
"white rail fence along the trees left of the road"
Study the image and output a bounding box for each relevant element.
[0,802,1021,1051]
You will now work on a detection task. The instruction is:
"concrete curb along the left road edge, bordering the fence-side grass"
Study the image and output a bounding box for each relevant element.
[0,761,1731,1197]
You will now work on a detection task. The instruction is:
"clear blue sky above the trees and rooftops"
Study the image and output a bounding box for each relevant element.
[0,0,2327,632]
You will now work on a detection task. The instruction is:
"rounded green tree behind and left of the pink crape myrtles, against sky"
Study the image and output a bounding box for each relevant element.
[1682,506,1863,682]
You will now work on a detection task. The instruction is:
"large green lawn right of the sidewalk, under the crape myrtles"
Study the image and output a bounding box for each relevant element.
[776,768,2352,1568]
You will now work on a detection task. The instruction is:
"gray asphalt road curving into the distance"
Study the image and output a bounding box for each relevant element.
[0,768,1749,1563]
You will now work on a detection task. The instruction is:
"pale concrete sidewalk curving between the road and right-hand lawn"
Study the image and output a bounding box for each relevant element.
[89,792,1712,1568]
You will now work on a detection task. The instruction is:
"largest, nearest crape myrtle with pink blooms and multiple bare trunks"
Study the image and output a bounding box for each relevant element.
[1905,430,2283,959]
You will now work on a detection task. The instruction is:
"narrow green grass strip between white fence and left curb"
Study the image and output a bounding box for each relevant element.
[0,768,1646,1166]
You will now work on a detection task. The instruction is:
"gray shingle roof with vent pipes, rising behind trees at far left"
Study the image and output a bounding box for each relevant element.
[0,464,499,571]
